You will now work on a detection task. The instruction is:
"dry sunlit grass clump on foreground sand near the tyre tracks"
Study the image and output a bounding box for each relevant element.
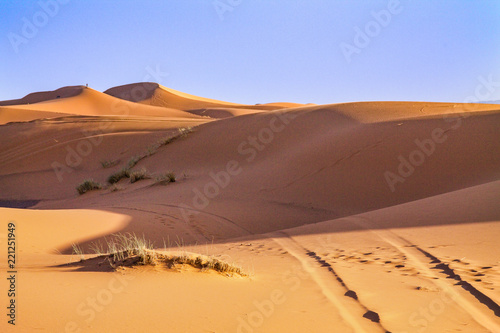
[87,233,246,276]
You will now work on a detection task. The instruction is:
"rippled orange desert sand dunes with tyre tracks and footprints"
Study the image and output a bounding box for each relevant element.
[0,83,500,333]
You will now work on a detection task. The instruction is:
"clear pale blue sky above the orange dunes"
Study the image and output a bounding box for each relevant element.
[0,0,500,104]
